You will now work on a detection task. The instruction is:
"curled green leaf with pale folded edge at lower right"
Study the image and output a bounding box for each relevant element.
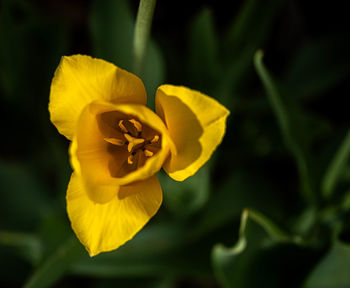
[211,209,302,287]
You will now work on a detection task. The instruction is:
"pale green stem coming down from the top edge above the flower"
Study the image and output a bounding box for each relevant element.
[133,0,156,75]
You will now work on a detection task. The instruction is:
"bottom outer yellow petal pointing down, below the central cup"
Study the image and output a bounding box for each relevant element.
[66,173,162,256]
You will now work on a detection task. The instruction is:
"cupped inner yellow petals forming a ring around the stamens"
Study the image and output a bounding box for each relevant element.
[70,101,175,196]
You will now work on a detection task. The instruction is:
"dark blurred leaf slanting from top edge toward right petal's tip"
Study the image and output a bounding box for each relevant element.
[217,0,284,109]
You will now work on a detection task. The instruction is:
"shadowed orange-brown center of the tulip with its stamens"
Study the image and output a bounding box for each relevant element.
[104,118,160,174]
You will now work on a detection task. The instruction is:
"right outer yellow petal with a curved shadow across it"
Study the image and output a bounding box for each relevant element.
[156,85,229,181]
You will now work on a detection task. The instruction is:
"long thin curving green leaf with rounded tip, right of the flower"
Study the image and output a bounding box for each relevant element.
[254,51,316,202]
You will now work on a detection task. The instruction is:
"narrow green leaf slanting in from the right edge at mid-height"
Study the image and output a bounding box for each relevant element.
[322,130,350,198]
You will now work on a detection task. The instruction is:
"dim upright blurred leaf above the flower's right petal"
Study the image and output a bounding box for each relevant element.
[188,8,222,92]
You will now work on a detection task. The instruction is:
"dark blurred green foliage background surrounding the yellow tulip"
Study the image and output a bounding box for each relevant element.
[0,0,350,288]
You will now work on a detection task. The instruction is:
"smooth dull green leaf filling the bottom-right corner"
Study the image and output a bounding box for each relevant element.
[304,241,350,288]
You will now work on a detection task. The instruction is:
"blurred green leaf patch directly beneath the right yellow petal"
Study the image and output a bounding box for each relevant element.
[159,164,210,217]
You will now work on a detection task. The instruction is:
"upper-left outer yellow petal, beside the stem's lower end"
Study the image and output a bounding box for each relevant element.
[49,55,146,140]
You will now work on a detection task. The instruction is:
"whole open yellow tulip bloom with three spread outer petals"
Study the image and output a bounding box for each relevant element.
[49,55,229,256]
